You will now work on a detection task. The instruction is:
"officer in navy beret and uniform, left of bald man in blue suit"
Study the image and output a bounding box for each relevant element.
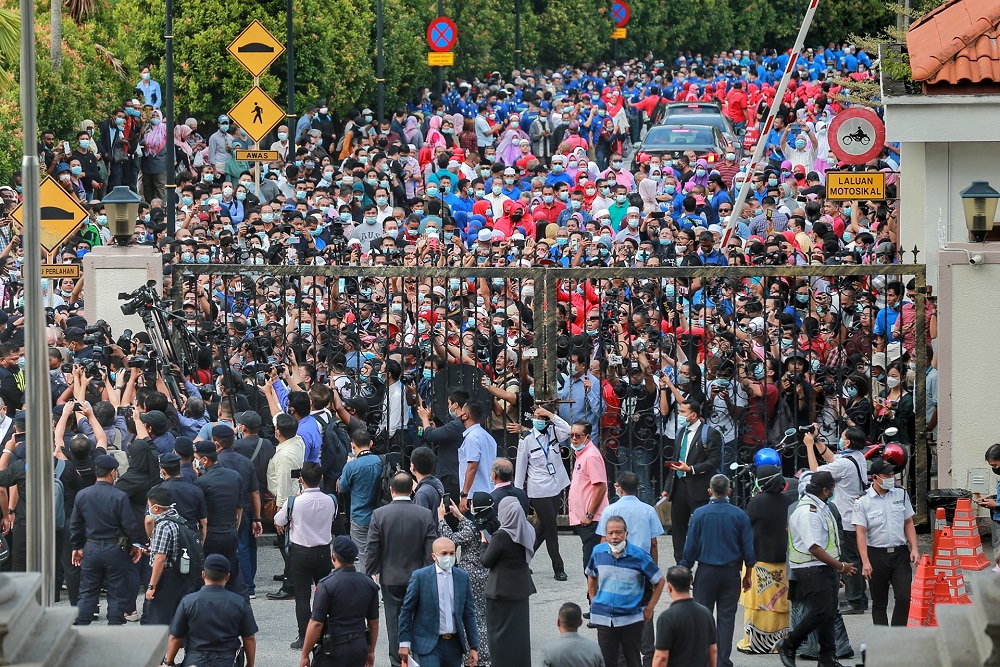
[300,535,379,667]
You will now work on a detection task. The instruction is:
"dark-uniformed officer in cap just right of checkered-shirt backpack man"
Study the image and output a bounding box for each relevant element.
[194,440,246,593]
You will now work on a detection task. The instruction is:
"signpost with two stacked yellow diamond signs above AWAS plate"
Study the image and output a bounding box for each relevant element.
[226,21,286,201]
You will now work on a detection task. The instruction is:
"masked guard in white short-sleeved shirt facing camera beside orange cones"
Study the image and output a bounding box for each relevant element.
[853,459,920,626]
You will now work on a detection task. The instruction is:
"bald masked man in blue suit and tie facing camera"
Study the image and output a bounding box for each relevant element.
[399,537,479,667]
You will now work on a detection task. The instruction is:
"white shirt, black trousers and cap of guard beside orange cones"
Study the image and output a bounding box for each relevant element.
[853,463,913,626]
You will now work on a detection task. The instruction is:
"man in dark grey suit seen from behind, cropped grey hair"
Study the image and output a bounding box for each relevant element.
[365,472,437,667]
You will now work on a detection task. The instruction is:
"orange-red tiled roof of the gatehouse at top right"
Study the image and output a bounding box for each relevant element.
[906,0,1000,84]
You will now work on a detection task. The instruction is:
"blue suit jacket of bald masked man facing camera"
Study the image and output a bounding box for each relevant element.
[399,565,479,656]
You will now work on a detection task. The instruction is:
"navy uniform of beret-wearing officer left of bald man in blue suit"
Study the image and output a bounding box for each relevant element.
[311,565,379,667]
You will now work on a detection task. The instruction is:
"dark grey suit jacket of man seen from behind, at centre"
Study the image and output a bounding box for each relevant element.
[365,499,438,587]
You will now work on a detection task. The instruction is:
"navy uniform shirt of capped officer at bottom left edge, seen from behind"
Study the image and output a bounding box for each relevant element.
[170,584,257,667]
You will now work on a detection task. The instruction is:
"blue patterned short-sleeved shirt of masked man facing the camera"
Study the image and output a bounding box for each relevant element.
[584,542,663,627]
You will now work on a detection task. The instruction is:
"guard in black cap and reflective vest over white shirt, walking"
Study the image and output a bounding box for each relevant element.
[777,470,854,667]
